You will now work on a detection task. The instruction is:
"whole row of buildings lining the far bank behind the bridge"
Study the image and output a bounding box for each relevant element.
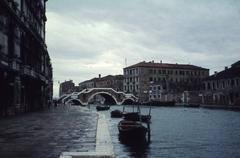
[60,61,240,105]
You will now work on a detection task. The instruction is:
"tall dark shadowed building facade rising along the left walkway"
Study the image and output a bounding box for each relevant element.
[0,0,53,116]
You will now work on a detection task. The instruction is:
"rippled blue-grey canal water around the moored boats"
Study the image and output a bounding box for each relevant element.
[95,106,240,158]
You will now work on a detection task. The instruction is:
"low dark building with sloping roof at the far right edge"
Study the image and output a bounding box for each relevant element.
[202,61,240,106]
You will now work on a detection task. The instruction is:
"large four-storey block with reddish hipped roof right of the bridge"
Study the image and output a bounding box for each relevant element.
[123,61,209,102]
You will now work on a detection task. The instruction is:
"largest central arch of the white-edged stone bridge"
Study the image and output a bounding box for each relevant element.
[87,92,118,105]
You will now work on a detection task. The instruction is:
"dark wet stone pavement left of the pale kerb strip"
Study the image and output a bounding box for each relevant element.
[0,106,98,158]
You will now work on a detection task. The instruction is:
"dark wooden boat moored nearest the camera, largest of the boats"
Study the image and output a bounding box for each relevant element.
[118,120,148,141]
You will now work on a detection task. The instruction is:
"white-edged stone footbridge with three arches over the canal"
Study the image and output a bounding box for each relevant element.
[59,88,138,105]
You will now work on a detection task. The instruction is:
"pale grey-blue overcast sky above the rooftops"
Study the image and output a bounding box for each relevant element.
[46,0,240,96]
